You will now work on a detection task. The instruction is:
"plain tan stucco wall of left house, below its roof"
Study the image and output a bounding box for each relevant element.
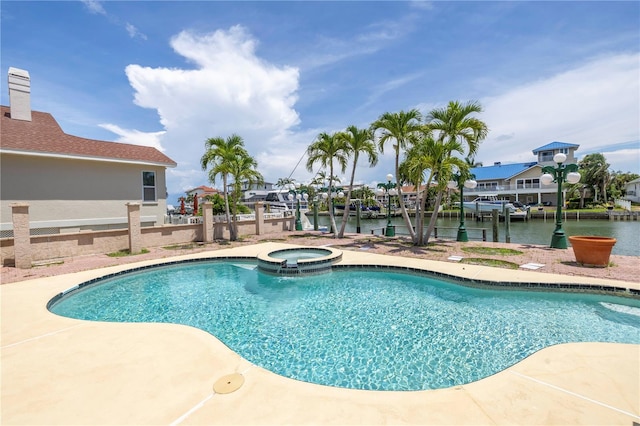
[0,154,166,227]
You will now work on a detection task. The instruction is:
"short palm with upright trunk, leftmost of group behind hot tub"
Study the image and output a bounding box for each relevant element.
[307,132,347,237]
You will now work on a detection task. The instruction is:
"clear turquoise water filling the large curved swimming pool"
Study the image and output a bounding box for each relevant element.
[50,262,640,390]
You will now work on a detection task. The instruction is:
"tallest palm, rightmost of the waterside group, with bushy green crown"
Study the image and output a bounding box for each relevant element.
[427,101,489,241]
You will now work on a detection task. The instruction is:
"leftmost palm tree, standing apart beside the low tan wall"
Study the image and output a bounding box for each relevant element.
[200,134,249,241]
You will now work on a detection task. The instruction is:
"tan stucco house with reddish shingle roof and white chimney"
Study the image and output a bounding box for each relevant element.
[0,68,176,237]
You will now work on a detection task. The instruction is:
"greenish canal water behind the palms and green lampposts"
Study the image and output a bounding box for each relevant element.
[308,214,640,256]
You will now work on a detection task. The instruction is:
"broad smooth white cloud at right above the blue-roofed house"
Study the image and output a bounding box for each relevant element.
[477,54,640,172]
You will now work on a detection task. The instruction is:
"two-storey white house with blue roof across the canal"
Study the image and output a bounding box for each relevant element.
[465,142,580,205]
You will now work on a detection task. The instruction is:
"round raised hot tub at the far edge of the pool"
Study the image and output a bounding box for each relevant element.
[258,247,342,274]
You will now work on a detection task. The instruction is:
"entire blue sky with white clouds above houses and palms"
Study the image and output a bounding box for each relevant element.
[0,0,640,202]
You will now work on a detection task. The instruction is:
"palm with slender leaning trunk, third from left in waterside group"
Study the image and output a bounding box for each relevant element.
[371,108,422,242]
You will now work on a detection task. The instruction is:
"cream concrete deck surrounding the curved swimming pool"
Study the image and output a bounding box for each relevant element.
[0,243,640,426]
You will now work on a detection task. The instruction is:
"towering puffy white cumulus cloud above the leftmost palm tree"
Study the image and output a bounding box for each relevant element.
[118,26,310,192]
